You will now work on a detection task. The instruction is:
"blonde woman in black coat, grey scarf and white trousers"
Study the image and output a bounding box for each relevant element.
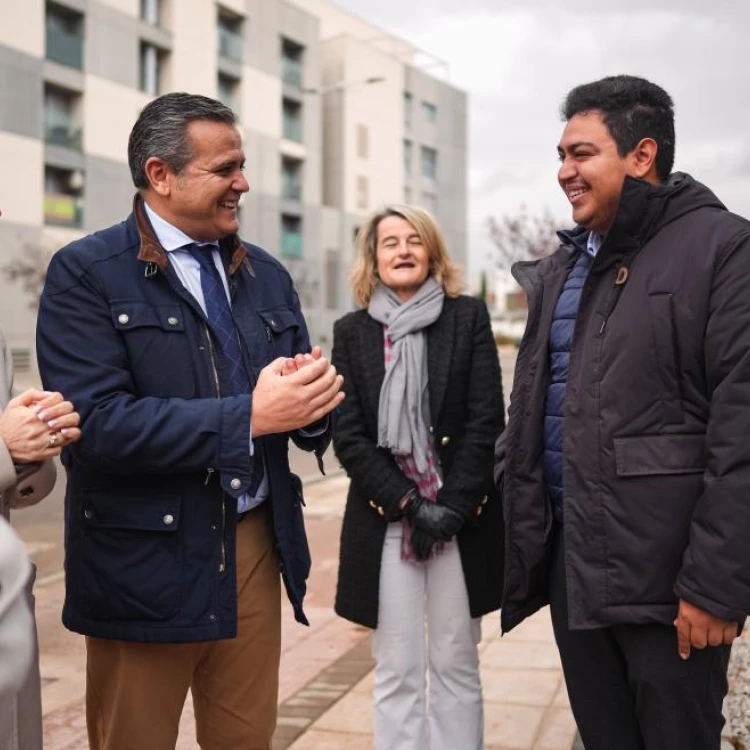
[333,205,504,750]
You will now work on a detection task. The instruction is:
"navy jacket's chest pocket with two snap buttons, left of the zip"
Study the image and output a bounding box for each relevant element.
[110,300,198,398]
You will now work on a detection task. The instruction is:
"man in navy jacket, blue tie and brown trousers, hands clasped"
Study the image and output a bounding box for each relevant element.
[37,94,343,750]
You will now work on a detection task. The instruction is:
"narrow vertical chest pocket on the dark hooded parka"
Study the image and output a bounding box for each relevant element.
[648,293,685,424]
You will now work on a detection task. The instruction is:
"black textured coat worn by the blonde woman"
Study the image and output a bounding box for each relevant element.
[332,297,505,628]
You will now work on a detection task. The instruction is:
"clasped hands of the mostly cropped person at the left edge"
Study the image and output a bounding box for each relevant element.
[0,389,81,464]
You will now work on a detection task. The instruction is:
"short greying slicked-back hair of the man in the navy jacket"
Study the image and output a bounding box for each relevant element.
[128,92,237,188]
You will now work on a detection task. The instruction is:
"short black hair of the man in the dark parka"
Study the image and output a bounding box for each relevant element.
[561,75,675,182]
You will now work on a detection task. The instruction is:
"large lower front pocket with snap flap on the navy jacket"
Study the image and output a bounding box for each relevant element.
[75,490,183,622]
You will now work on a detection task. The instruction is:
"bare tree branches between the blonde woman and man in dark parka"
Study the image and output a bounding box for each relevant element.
[487,205,559,268]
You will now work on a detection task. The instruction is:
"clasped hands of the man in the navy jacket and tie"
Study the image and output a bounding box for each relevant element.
[252,346,344,437]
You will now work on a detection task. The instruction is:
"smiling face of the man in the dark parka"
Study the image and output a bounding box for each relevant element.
[557,110,633,234]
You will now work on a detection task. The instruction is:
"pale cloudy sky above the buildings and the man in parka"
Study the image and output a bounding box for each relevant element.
[337,0,750,274]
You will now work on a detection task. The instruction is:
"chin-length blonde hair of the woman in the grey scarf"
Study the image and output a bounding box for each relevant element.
[350,203,464,307]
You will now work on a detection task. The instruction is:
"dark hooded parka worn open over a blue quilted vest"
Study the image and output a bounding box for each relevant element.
[502,174,750,631]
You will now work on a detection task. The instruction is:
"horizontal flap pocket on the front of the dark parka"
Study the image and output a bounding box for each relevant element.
[615,434,706,477]
